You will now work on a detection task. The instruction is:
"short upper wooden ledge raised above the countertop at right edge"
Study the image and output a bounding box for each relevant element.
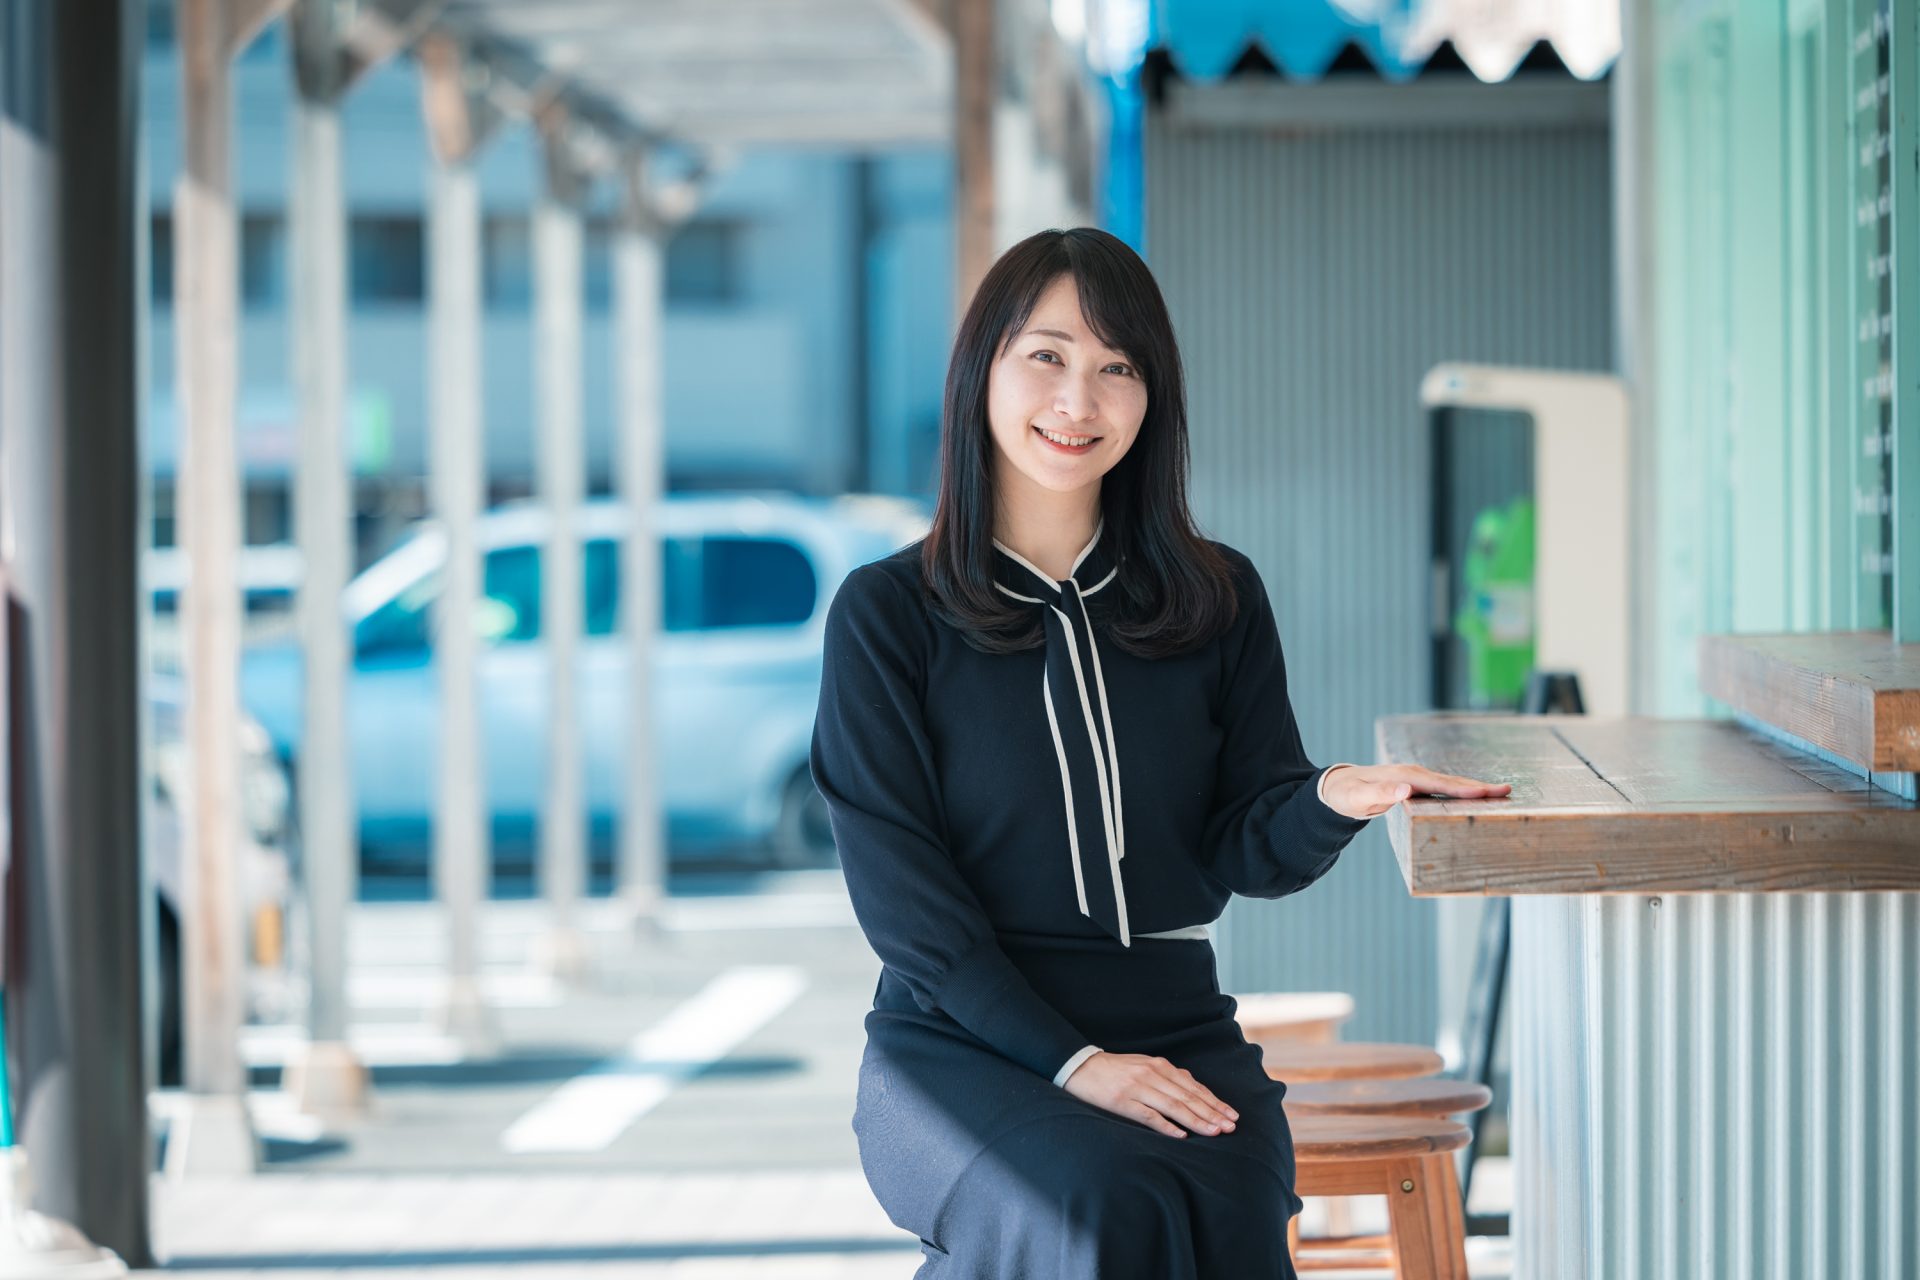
[1699,631,1920,771]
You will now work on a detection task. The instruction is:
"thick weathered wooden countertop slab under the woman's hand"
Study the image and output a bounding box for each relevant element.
[1375,712,1920,896]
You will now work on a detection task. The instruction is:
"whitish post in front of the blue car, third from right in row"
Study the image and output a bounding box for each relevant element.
[428,157,497,1055]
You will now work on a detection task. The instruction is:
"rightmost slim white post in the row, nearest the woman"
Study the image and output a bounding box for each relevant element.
[612,155,666,929]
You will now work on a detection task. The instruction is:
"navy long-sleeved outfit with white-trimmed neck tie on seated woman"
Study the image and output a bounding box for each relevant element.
[812,524,1367,1280]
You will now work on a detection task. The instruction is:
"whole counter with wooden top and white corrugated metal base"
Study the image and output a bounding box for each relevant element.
[1377,714,1920,1280]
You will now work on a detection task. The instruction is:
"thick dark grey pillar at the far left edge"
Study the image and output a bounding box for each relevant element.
[0,0,152,1267]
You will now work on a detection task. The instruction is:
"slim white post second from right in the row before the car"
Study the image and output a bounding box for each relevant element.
[534,113,586,979]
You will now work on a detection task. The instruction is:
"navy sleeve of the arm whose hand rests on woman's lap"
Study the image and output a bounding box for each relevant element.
[810,566,1089,1079]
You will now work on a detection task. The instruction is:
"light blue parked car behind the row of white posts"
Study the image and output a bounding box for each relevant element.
[242,493,929,871]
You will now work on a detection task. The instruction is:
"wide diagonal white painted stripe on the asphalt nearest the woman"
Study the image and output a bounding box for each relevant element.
[499,965,806,1155]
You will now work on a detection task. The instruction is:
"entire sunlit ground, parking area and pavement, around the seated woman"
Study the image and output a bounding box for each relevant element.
[139,871,1511,1280]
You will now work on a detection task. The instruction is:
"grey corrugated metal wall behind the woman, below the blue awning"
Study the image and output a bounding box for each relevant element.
[1146,97,1613,1040]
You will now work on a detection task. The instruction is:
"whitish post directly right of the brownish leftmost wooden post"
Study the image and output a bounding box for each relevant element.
[284,40,367,1125]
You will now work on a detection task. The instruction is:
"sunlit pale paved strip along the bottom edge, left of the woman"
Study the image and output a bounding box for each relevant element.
[156,1169,920,1280]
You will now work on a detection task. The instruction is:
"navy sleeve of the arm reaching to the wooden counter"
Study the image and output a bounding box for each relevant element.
[1202,553,1367,898]
